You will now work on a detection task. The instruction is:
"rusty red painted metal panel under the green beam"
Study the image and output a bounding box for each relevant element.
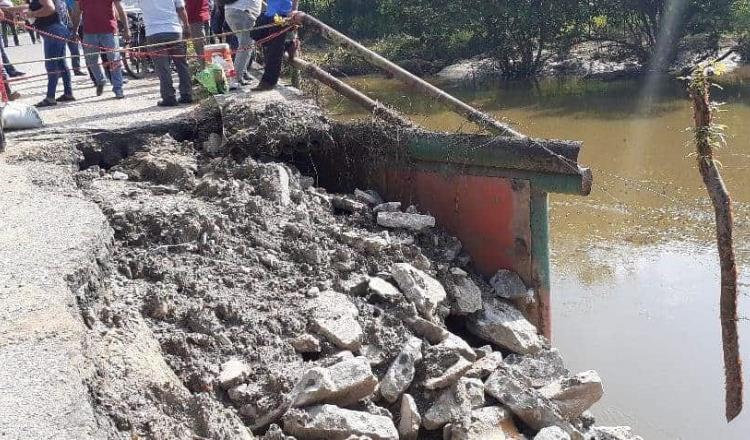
[380,170,531,283]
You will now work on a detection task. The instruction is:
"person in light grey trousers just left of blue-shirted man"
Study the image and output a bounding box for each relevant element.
[222,0,263,90]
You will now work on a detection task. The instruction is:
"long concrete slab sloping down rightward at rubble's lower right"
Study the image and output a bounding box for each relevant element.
[484,365,583,440]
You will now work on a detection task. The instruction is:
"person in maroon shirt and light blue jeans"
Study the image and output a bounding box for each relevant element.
[72,0,130,99]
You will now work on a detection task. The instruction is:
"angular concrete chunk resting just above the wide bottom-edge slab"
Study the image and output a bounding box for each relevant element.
[291,357,378,407]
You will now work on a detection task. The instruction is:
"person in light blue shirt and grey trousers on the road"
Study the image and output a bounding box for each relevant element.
[137,0,193,107]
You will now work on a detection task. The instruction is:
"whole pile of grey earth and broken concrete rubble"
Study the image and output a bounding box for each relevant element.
[77,136,639,440]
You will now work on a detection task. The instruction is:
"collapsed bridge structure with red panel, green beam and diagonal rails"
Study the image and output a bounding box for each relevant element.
[291,15,592,337]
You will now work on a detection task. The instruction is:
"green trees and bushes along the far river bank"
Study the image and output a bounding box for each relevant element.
[302,0,750,77]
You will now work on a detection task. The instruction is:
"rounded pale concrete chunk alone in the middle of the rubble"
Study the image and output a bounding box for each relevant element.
[313,290,362,351]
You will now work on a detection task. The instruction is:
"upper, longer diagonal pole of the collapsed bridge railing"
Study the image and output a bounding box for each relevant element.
[298,13,526,139]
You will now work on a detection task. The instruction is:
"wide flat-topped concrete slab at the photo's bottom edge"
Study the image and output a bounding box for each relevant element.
[284,405,398,440]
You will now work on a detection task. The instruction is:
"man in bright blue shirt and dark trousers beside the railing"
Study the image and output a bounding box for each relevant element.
[253,0,299,92]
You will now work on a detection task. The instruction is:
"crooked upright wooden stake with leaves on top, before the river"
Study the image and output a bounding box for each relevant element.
[689,67,743,421]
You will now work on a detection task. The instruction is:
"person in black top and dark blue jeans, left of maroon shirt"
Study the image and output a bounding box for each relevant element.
[27,0,75,107]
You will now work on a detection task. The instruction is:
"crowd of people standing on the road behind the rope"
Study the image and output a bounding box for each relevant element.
[0,0,299,107]
